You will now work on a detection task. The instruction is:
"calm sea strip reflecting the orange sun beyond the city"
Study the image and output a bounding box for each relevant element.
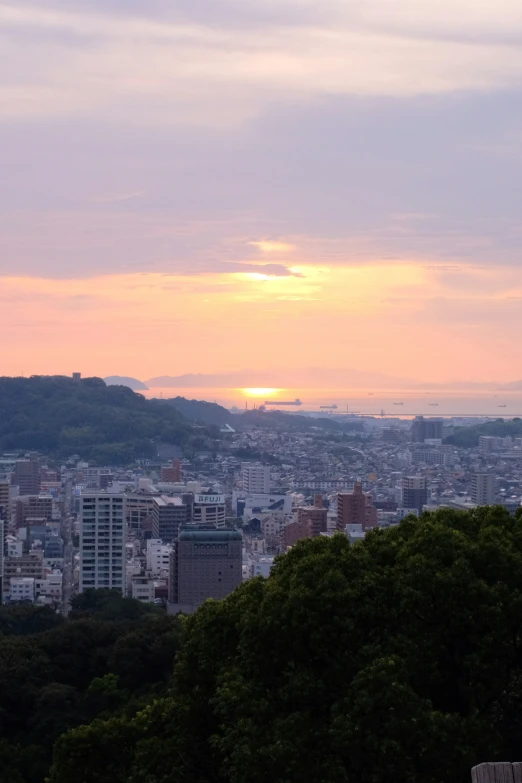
[141,387,522,419]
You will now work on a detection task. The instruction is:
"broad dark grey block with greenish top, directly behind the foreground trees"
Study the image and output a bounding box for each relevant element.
[169,530,242,613]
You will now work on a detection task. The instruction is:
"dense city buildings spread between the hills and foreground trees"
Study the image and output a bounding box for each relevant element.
[0,380,522,615]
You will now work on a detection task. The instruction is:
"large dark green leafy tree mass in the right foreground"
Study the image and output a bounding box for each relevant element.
[50,507,522,783]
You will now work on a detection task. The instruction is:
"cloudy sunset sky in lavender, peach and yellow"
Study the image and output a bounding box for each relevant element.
[0,0,522,387]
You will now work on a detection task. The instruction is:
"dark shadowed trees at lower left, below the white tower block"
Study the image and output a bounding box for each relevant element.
[0,590,180,783]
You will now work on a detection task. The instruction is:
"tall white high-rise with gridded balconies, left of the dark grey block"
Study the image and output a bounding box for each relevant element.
[79,492,126,594]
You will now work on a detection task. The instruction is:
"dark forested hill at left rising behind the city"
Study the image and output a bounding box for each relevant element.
[0,376,216,464]
